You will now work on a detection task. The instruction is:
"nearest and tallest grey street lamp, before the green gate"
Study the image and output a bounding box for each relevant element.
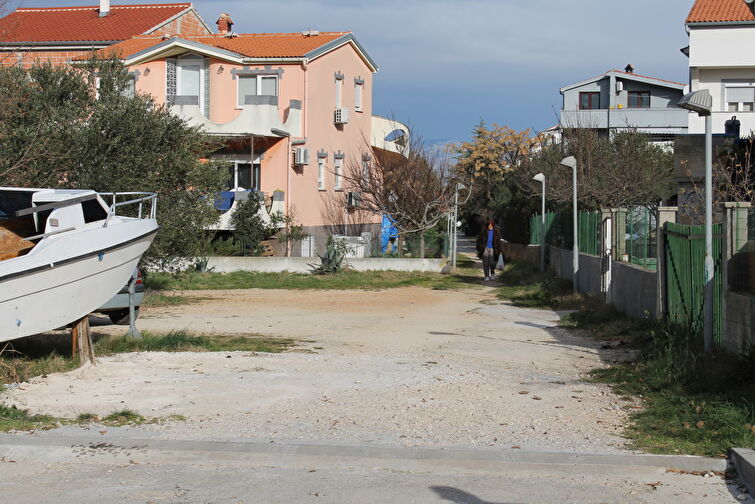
[677,89,715,353]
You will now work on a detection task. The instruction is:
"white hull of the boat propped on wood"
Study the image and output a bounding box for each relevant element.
[0,219,158,342]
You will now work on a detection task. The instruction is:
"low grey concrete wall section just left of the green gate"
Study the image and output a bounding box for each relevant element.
[608,261,658,318]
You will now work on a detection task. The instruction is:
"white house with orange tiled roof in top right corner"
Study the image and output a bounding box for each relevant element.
[684,0,755,136]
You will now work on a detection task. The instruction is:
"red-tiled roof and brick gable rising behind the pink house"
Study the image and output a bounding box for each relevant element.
[0,0,212,66]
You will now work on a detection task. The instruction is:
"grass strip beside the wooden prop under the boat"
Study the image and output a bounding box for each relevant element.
[95,331,296,355]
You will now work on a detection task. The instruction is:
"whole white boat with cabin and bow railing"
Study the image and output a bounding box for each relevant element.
[0,187,158,342]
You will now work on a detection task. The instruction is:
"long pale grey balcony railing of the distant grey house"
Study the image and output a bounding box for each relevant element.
[561,108,687,134]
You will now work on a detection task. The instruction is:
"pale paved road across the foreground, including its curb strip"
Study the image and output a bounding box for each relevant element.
[0,431,739,504]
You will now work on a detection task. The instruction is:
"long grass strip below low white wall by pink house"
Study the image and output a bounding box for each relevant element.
[145,263,478,290]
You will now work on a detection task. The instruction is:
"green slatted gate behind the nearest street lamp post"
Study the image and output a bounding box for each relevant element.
[664,222,723,344]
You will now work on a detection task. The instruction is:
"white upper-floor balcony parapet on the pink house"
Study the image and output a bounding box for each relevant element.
[170,96,302,137]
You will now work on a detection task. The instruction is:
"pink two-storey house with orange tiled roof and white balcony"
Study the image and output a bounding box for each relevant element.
[97,14,408,255]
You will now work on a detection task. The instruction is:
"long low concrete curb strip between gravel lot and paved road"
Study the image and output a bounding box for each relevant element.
[0,434,726,472]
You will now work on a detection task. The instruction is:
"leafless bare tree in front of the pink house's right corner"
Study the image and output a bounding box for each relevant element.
[343,136,471,257]
